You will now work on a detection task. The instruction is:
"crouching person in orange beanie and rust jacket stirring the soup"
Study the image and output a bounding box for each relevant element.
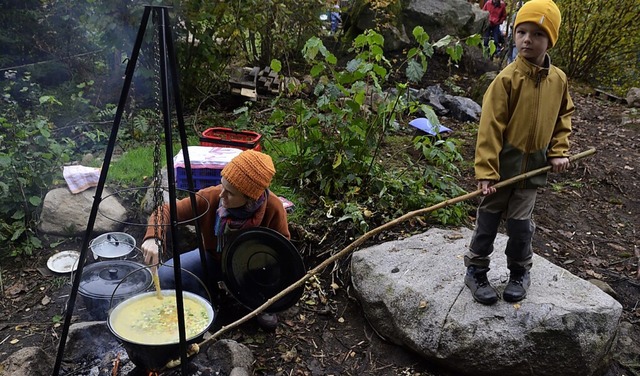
[141,150,291,330]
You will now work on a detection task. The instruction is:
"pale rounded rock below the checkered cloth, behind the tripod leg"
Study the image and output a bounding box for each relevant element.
[38,188,127,236]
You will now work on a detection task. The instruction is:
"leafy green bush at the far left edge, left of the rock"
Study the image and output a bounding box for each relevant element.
[0,76,74,256]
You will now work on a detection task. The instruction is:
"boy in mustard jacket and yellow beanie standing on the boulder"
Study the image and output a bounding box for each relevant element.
[464,0,574,305]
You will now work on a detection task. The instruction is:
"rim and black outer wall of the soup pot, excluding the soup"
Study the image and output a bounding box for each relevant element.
[107,290,215,372]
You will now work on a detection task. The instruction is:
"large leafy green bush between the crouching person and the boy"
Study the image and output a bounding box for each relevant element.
[270,27,480,232]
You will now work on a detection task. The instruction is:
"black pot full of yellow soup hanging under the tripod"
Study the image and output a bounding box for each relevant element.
[107,290,215,371]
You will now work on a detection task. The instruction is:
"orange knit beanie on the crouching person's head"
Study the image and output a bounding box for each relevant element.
[221,150,276,200]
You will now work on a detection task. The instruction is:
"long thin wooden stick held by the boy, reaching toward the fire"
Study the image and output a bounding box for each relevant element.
[199,148,596,348]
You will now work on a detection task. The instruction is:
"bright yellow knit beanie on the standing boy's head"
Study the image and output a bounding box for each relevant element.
[513,0,562,48]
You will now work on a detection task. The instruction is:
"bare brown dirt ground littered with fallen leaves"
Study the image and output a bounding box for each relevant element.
[0,83,640,376]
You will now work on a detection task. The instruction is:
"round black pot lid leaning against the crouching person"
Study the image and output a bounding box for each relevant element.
[222,227,306,313]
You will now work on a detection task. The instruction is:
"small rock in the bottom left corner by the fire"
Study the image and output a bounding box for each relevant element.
[0,347,54,376]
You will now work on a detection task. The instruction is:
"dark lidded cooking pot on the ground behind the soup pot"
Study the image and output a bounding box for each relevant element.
[78,260,153,321]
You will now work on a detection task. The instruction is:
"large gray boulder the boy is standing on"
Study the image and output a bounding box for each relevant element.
[351,228,622,376]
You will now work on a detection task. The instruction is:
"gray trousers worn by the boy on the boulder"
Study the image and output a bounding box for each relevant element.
[464,187,537,272]
